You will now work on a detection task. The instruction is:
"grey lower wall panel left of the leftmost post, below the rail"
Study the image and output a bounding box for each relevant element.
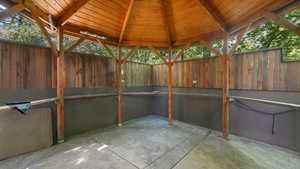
[0,108,53,160]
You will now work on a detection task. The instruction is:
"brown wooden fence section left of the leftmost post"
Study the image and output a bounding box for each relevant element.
[0,42,51,89]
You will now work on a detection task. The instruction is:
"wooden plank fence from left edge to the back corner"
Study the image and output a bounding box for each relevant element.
[0,41,152,89]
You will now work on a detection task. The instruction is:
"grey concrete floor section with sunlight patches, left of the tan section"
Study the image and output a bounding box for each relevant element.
[0,116,208,169]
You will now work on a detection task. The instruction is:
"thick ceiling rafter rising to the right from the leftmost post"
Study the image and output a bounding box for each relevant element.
[57,0,90,25]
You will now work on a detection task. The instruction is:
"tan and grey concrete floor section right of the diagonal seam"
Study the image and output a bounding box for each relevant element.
[174,133,300,169]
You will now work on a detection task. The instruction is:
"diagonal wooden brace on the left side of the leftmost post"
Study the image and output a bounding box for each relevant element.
[31,9,57,55]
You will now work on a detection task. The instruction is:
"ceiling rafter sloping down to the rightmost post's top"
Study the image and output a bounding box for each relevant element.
[196,0,227,32]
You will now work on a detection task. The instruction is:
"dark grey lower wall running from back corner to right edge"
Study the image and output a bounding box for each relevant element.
[153,87,300,152]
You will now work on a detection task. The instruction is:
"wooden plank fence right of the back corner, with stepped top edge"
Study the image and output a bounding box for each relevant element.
[152,48,300,91]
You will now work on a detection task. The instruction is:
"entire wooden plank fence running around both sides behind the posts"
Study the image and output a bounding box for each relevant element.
[0,41,300,91]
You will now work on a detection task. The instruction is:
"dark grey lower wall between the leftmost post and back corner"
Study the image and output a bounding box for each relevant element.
[65,87,153,137]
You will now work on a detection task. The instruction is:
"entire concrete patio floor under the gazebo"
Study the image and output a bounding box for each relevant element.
[0,116,300,169]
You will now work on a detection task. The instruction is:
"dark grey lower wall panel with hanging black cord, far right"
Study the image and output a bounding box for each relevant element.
[230,90,300,151]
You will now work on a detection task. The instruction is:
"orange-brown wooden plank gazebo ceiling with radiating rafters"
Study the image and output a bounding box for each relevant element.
[2,0,293,47]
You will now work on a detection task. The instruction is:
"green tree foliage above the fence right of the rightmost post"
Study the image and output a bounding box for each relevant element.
[237,9,300,61]
